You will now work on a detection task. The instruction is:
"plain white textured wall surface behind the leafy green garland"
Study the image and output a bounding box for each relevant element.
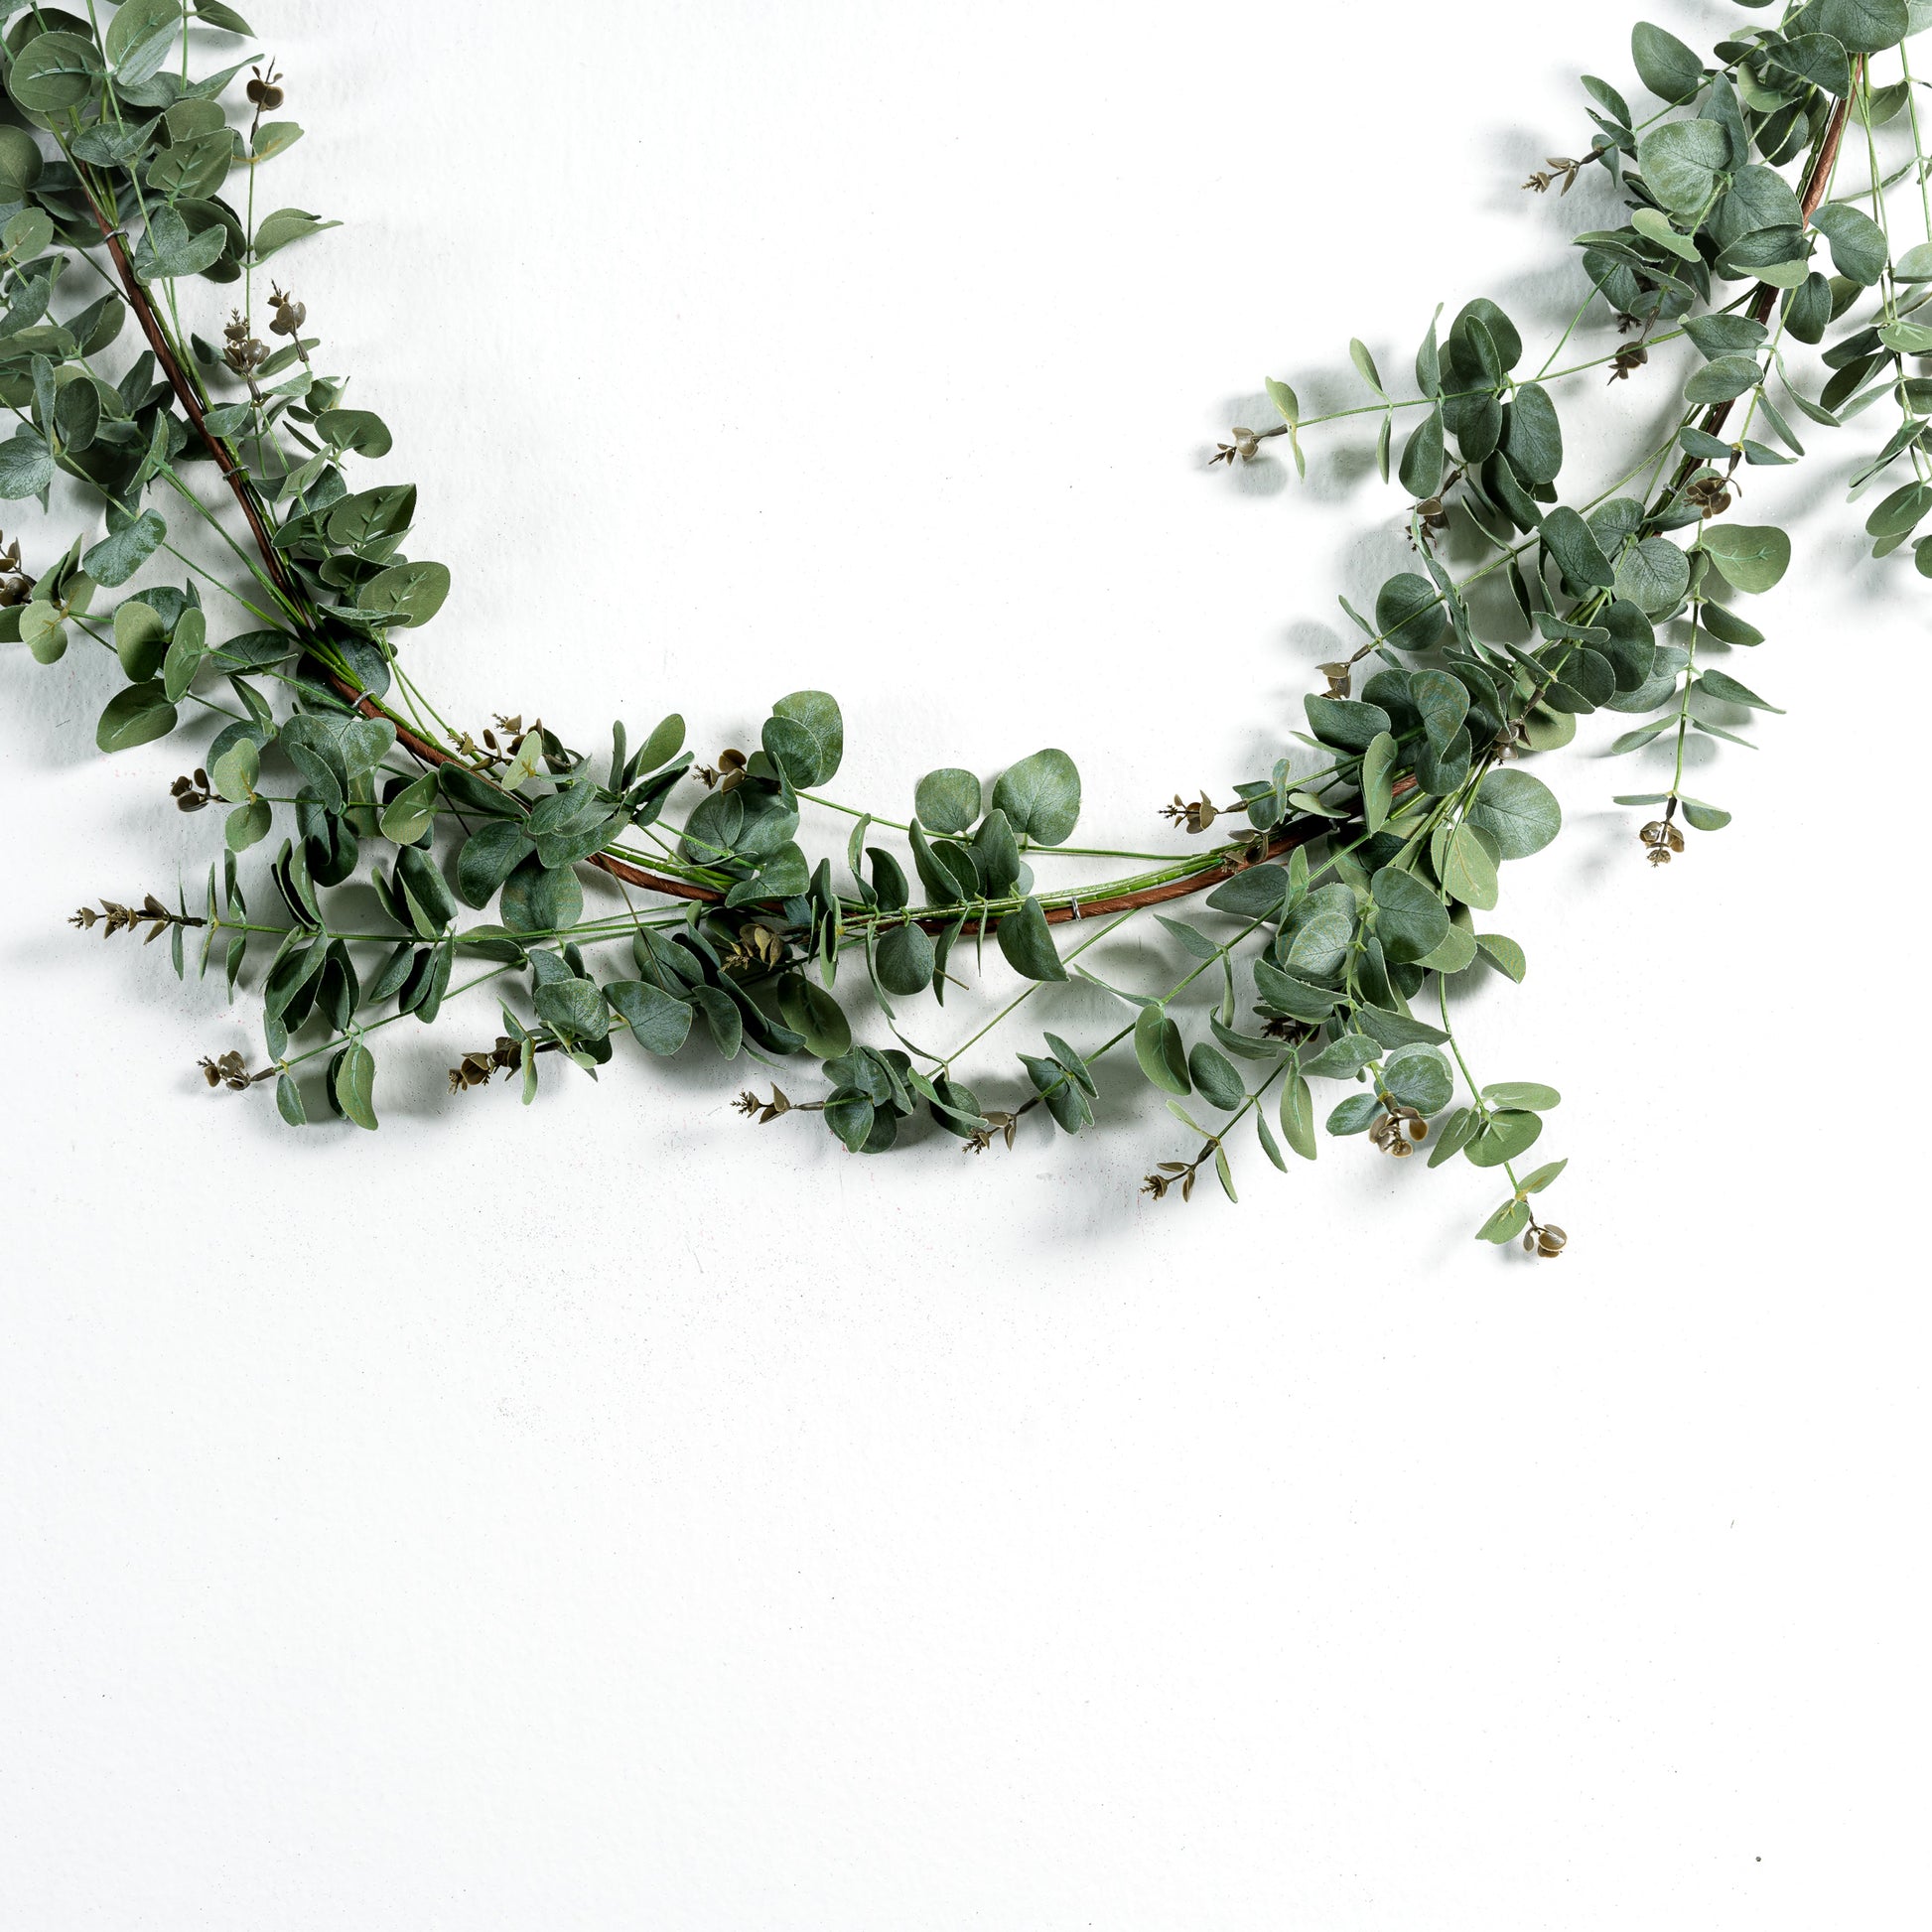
[0,0,1928,1932]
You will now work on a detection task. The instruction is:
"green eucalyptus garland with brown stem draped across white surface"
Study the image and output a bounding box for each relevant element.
[0,0,1932,1256]
